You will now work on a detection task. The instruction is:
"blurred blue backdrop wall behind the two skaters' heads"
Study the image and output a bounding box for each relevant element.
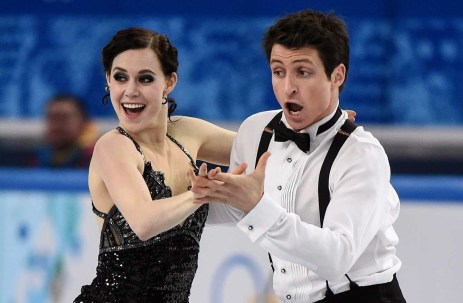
[0,0,463,126]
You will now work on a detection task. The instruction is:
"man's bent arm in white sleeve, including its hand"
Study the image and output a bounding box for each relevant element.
[190,132,393,279]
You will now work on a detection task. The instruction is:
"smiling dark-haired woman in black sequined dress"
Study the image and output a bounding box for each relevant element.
[74,28,235,303]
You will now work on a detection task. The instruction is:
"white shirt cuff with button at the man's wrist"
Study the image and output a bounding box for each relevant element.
[237,193,285,242]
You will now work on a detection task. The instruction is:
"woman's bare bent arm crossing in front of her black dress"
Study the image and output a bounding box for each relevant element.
[89,133,199,240]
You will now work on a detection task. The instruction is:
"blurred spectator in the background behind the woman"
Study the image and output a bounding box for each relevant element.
[30,94,100,168]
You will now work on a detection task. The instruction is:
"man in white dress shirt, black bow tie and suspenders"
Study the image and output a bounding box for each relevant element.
[190,10,405,303]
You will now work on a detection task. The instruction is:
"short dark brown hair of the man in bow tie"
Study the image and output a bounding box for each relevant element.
[262,10,350,91]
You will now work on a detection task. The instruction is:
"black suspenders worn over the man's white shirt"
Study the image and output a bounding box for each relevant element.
[255,108,358,297]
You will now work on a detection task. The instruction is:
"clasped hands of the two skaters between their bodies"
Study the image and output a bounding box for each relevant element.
[188,152,270,213]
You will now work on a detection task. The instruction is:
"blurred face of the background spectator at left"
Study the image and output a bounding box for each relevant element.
[46,100,85,149]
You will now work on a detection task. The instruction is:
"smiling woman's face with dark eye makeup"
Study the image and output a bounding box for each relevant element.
[107,48,177,132]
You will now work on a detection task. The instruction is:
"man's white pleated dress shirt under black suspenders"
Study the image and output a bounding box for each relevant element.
[207,106,401,302]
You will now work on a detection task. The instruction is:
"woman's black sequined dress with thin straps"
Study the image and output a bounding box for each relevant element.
[74,127,208,303]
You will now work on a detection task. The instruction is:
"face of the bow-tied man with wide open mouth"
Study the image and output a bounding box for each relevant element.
[270,44,345,131]
